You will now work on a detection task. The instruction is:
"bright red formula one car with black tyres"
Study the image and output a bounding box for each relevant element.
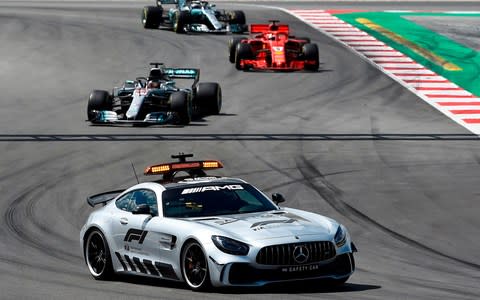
[228,20,319,71]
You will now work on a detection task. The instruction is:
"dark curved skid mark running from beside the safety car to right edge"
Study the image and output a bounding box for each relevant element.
[298,156,480,269]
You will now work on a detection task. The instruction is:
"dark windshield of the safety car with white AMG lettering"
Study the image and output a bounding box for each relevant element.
[162,183,277,218]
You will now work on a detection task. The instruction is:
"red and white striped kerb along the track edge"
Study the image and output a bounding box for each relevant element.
[283,9,480,135]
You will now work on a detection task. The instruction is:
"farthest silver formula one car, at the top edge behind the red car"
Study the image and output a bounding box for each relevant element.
[142,0,248,33]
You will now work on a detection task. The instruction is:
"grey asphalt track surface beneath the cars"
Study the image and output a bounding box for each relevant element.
[0,1,480,299]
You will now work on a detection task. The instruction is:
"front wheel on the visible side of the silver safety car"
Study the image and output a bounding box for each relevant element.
[180,240,211,291]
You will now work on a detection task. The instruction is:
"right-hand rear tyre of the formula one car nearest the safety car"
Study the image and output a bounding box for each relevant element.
[195,82,222,115]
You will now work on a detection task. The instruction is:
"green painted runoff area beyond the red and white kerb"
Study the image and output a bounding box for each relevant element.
[334,12,480,96]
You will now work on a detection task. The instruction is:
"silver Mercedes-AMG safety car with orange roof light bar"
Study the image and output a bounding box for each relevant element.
[80,154,356,290]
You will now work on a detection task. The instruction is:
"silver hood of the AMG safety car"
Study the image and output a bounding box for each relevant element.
[189,209,338,242]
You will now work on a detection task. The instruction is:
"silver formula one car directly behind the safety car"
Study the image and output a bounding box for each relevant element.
[87,62,222,125]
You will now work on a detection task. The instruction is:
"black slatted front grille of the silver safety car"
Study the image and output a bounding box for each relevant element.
[257,241,336,266]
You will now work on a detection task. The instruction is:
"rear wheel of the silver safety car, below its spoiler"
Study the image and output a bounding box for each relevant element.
[83,229,114,280]
